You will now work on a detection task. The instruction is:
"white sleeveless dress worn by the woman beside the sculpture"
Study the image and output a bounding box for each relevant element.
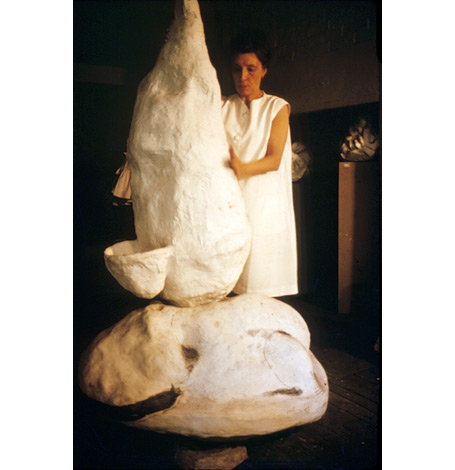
[222,93,298,297]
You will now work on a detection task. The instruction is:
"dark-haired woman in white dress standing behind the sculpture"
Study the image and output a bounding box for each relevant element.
[222,31,298,297]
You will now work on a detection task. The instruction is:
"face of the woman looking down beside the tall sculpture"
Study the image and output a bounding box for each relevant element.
[232,52,267,101]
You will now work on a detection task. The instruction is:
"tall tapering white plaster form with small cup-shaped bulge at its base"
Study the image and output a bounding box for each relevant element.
[104,0,251,307]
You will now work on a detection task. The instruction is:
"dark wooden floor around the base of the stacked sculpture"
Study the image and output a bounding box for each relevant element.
[74,347,380,470]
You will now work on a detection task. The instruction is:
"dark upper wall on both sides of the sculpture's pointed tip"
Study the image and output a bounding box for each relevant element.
[74,0,380,113]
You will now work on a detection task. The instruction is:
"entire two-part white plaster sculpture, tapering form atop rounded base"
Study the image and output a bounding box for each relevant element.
[79,0,328,448]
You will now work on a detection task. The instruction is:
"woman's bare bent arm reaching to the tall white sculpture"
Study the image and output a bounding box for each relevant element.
[229,105,289,178]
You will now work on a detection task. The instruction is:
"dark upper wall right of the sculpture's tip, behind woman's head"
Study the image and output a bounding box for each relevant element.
[205,0,379,113]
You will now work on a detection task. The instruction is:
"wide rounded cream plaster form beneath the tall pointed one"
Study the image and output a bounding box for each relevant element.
[79,294,329,438]
